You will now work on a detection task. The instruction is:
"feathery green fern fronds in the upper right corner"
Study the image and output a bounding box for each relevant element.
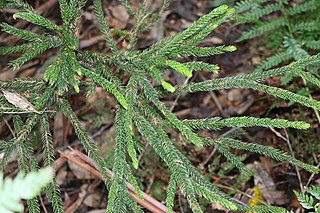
[235,0,320,72]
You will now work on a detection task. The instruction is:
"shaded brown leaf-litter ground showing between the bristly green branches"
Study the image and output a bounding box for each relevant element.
[0,0,320,213]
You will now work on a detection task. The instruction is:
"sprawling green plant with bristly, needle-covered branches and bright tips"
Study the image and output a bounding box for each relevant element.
[0,0,320,213]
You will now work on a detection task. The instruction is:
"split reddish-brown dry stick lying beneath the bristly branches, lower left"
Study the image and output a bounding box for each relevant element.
[58,147,167,213]
